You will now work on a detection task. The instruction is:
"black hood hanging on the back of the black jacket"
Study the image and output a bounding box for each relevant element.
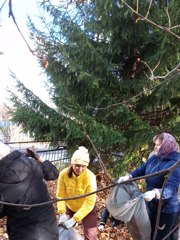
[0,150,33,184]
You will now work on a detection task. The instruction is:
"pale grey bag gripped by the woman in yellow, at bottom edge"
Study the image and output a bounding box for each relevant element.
[59,225,83,240]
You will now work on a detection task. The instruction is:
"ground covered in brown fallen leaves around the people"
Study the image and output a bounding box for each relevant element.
[0,173,132,240]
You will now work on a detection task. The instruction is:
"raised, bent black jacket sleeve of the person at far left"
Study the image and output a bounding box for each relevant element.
[41,160,59,181]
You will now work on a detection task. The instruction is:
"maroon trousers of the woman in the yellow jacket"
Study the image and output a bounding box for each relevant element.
[66,208,97,240]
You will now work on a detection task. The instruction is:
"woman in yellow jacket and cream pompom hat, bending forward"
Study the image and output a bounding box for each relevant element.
[57,146,97,240]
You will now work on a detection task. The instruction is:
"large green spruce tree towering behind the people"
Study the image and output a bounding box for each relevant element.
[8,0,180,171]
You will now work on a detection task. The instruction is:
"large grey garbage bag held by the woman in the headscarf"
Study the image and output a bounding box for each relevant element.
[106,182,151,240]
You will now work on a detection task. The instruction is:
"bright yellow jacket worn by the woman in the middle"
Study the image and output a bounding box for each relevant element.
[56,168,97,222]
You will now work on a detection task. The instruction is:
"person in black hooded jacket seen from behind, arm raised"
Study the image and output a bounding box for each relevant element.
[0,143,59,240]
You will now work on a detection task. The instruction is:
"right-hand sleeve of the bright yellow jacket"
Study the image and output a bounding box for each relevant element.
[73,175,97,222]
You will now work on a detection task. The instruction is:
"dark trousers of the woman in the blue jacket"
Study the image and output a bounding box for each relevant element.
[149,212,178,240]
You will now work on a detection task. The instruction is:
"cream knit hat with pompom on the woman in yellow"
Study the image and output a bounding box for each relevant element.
[71,146,89,166]
